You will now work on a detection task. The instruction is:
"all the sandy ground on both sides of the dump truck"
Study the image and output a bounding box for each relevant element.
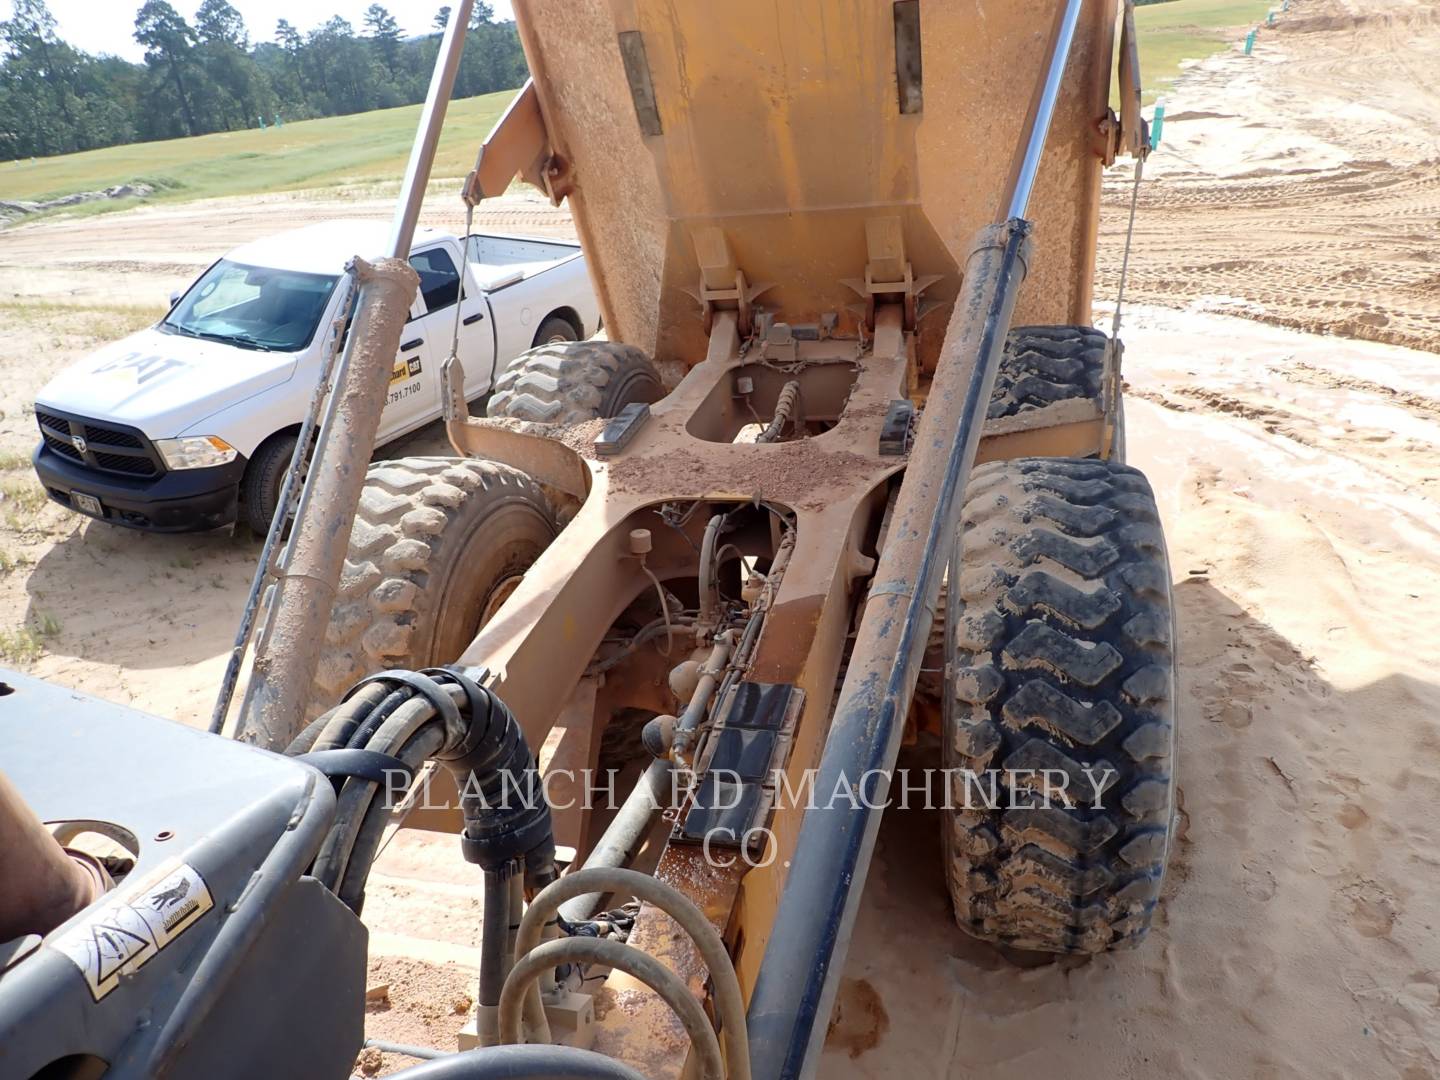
[0,0,1440,1080]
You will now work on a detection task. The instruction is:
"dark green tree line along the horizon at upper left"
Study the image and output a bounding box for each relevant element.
[0,0,526,158]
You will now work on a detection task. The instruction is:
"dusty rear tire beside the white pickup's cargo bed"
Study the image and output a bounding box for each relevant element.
[485,341,665,423]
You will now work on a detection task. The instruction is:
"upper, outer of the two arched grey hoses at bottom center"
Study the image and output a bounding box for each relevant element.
[512,867,750,1080]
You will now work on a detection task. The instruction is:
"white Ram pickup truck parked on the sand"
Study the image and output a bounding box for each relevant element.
[35,222,599,533]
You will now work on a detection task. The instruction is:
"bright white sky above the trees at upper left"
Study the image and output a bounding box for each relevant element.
[43,0,511,60]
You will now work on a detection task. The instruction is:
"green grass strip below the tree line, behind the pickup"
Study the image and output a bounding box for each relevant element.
[0,91,514,213]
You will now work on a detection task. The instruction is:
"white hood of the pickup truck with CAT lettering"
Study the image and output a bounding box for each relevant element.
[36,330,295,439]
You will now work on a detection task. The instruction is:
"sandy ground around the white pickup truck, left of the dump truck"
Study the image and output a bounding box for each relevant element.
[0,181,573,723]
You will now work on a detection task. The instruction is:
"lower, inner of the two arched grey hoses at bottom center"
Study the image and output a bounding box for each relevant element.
[500,937,724,1080]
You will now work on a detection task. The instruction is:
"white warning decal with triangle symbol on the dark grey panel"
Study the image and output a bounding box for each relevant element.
[46,860,215,1001]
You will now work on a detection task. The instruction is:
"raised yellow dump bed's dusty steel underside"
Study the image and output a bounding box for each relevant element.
[516,0,1116,367]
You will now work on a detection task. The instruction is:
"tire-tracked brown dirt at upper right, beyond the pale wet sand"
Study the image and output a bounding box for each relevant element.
[1099,0,1440,350]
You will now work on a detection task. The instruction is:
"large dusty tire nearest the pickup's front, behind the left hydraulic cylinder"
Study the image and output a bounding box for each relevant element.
[308,458,556,716]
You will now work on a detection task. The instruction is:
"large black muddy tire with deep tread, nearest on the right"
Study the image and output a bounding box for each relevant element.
[945,458,1175,953]
